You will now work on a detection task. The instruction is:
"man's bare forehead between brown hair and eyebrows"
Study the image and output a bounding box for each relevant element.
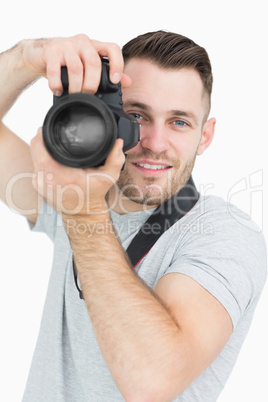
[123,59,205,120]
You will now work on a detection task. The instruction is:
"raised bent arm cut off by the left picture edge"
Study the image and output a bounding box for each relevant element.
[0,42,38,221]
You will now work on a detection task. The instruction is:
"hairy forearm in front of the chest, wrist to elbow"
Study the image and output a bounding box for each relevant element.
[64,214,182,401]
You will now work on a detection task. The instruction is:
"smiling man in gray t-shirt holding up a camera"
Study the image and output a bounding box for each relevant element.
[0,31,266,402]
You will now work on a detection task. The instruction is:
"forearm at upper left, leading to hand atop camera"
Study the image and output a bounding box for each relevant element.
[0,40,38,120]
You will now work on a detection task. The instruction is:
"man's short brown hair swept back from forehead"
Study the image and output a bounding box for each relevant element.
[122,31,213,112]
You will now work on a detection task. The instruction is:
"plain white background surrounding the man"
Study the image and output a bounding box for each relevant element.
[0,0,268,402]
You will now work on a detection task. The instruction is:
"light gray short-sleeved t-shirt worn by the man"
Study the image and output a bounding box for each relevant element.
[23,196,266,402]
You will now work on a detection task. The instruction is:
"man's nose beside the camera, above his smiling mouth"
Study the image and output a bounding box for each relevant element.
[140,123,169,154]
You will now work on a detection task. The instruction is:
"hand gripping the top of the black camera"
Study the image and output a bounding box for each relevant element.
[23,34,131,96]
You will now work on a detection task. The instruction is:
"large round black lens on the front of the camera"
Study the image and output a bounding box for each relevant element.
[43,94,117,167]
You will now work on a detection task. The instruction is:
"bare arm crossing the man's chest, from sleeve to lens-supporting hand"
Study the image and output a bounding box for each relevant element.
[29,133,232,402]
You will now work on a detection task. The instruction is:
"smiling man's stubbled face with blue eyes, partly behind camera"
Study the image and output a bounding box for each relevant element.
[109,59,215,212]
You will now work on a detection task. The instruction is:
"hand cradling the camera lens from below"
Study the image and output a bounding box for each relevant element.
[31,128,125,216]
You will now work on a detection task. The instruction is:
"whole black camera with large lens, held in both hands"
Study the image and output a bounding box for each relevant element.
[43,58,140,168]
